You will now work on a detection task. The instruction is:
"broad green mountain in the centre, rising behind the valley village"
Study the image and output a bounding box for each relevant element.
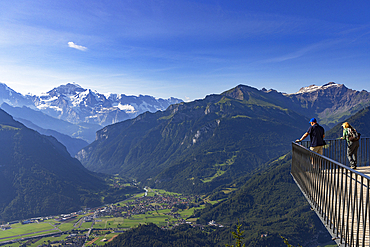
[77,88,308,193]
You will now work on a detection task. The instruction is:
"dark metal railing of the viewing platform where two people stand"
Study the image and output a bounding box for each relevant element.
[291,138,370,247]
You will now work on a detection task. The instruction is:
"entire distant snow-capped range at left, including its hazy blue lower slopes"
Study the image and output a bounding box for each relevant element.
[0,83,182,142]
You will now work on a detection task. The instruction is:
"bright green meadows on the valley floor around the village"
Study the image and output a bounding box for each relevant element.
[0,189,212,247]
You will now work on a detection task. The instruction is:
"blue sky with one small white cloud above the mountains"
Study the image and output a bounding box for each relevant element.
[0,0,370,100]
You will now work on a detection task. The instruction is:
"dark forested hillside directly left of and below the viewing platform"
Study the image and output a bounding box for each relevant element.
[195,154,330,246]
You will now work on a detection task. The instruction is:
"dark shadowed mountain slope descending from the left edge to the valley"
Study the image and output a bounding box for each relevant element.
[0,110,107,221]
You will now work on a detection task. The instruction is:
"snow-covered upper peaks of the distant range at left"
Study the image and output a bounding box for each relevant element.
[0,83,182,126]
